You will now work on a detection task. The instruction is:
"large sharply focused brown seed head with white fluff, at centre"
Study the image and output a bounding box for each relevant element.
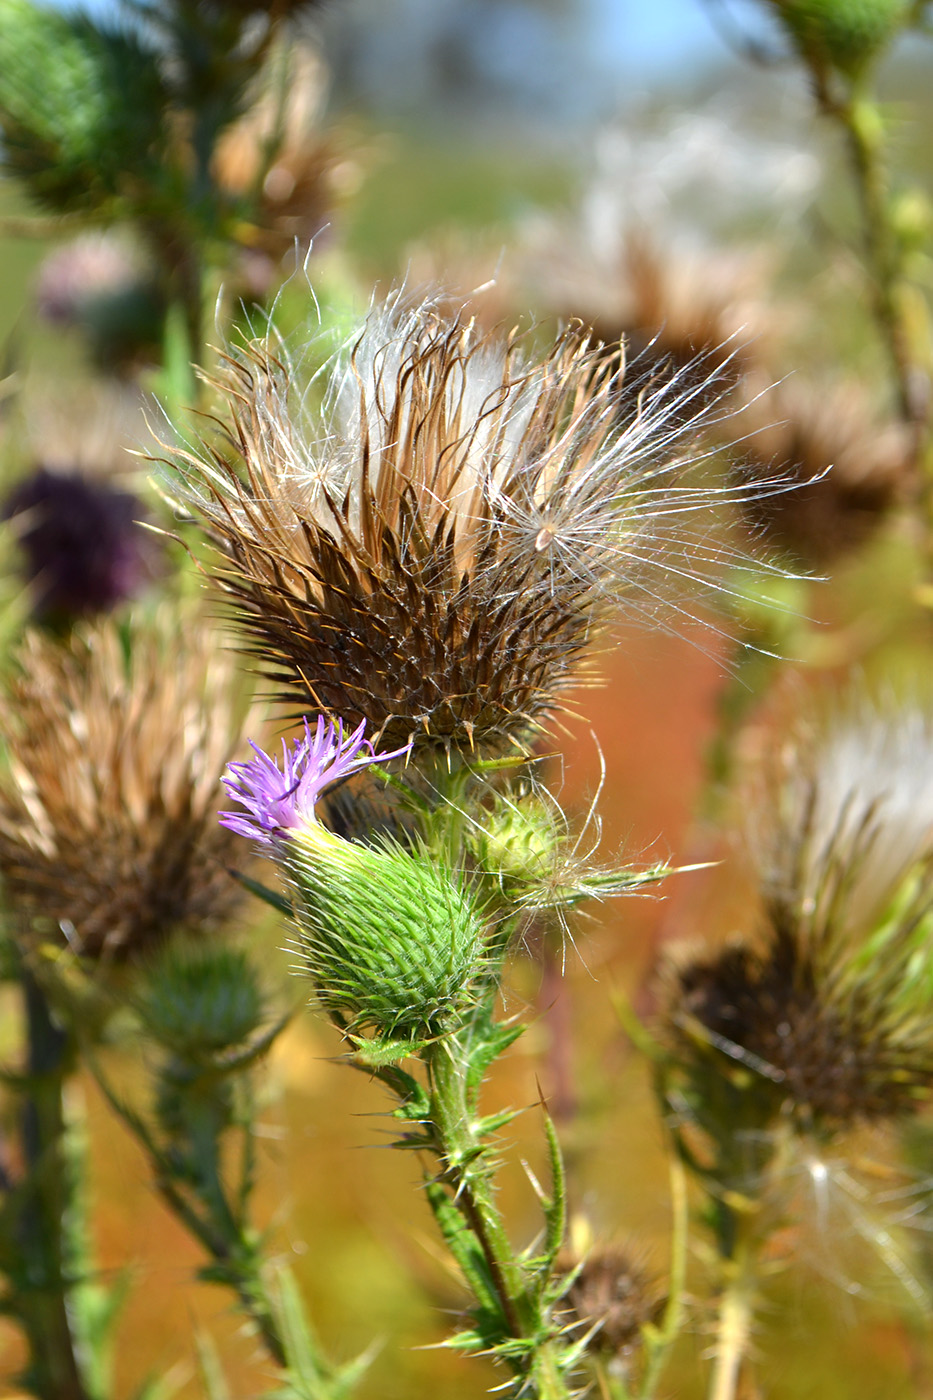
[165,289,778,752]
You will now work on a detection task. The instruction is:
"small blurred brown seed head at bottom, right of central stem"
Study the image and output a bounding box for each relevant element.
[562,1245,664,1357]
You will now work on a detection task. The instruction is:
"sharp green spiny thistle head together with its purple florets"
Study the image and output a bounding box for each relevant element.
[220,715,482,1036]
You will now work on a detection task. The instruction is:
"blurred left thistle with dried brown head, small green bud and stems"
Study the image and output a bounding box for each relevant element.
[0,616,350,1400]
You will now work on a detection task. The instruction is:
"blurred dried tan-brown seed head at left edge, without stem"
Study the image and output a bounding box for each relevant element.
[0,617,246,959]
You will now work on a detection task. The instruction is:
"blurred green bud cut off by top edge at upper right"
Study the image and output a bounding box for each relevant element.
[772,0,911,78]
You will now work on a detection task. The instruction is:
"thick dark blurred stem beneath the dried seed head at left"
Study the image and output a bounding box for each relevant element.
[15,969,94,1400]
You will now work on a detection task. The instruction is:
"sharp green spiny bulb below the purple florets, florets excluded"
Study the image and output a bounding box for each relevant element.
[287,823,482,1036]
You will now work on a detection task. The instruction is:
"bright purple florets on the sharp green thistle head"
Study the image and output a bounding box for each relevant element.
[220,715,412,846]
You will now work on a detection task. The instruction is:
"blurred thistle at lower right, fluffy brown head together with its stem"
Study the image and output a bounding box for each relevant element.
[658,710,933,1400]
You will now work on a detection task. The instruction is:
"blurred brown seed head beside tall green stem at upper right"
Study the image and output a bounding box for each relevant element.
[740,381,912,567]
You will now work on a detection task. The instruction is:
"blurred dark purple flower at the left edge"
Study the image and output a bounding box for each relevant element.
[0,468,158,619]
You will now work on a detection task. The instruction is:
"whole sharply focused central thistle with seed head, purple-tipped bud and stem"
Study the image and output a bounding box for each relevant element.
[152,287,801,1400]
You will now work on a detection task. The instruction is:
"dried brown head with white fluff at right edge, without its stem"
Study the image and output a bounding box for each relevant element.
[665,710,933,1130]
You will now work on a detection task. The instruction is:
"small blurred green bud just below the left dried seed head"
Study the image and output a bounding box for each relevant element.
[139,945,265,1058]
